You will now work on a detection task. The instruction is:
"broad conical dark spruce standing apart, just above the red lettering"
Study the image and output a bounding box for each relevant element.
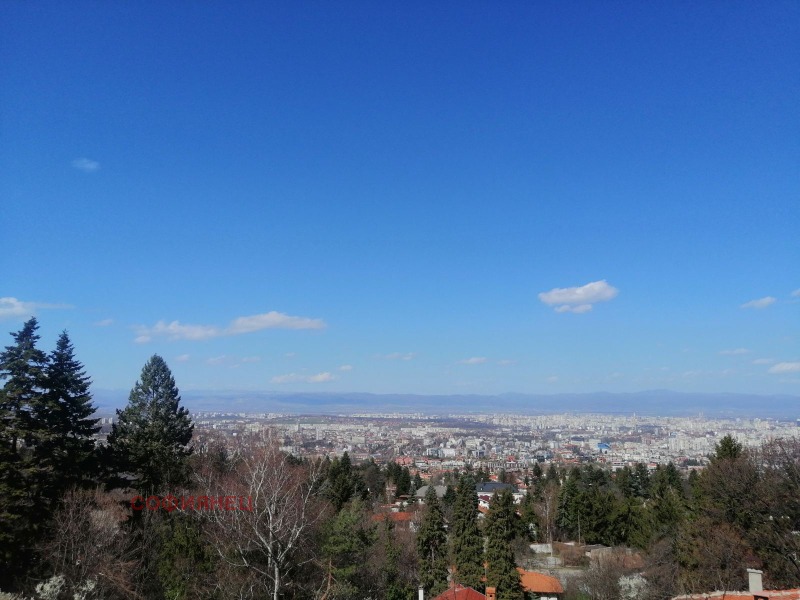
[108,354,194,493]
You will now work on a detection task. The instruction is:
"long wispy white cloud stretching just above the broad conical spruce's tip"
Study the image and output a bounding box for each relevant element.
[135,310,325,343]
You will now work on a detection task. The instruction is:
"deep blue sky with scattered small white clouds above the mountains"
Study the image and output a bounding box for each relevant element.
[0,0,800,394]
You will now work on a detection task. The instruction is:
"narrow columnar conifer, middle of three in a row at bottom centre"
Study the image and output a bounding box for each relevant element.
[450,475,484,591]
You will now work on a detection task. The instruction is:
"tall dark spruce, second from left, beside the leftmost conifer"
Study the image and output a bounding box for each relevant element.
[34,331,100,500]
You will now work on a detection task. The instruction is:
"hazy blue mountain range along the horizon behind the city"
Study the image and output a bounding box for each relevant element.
[94,390,800,420]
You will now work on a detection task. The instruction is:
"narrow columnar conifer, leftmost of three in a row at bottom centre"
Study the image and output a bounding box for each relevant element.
[417,486,447,596]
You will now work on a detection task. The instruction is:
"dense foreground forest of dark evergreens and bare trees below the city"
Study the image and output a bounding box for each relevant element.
[0,318,800,600]
